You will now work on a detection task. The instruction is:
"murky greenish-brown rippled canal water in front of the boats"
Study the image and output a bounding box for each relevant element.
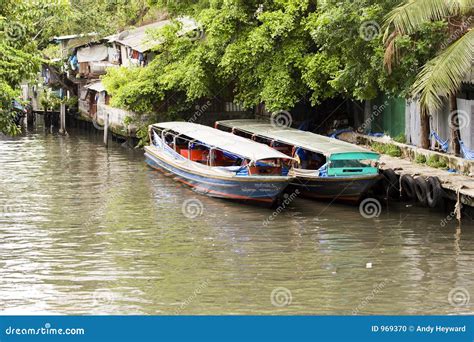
[0,125,474,315]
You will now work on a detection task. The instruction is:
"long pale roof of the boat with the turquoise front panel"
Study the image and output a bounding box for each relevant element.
[216,120,378,157]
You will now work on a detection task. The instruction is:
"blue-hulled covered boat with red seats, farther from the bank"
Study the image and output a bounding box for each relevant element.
[145,122,292,205]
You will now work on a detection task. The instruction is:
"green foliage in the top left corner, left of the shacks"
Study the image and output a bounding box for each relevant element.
[0,0,160,134]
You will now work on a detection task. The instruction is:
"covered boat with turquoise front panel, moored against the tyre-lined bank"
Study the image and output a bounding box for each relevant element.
[215,120,381,202]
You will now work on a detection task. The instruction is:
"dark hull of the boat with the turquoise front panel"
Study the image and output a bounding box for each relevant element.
[289,175,380,203]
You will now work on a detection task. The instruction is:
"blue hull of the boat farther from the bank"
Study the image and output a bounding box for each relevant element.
[145,149,290,205]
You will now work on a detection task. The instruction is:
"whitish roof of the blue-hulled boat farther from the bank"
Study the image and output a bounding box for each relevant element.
[152,121,293,161]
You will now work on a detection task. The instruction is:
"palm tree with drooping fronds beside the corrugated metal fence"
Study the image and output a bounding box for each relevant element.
[385,0,474,154]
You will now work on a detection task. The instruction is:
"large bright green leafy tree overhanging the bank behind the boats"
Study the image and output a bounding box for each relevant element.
[104,0,445,122]
